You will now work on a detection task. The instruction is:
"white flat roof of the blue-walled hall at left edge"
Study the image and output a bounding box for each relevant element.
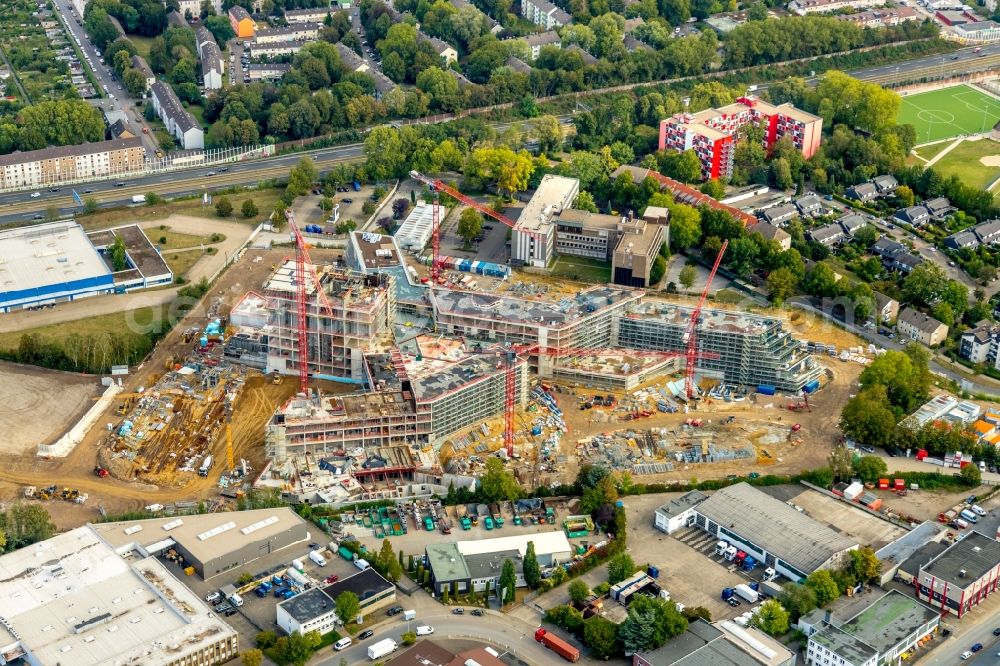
[0,221,111,300]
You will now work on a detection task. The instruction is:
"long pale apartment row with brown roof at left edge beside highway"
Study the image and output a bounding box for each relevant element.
[0,137,146,189]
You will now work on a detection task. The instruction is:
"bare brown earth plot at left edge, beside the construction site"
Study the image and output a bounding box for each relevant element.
[0,362,100,454]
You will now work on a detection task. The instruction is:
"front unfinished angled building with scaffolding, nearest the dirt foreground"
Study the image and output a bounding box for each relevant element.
[265,336,528,460]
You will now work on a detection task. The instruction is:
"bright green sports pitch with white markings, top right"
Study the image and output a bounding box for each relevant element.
[896,85,1000,144]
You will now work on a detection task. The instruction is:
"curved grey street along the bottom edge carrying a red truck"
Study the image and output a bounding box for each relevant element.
[314,600,572,666]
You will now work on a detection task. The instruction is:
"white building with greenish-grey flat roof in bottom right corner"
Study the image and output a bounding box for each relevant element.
[806,590,941,666]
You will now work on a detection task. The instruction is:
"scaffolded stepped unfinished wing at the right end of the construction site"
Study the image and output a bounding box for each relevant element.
[614,301,823,393]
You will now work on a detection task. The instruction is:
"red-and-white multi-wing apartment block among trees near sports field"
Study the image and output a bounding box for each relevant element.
[659,96,823,178]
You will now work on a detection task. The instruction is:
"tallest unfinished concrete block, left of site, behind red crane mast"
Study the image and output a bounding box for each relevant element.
[256,260,396,384]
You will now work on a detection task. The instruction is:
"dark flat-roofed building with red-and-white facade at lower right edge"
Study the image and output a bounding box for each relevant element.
[916,531,1000,617]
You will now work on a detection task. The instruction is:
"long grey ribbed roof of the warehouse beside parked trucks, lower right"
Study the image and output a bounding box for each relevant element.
[697,483,858,574]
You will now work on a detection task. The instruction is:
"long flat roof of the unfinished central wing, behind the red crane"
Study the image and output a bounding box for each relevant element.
[431,285,642,328]
